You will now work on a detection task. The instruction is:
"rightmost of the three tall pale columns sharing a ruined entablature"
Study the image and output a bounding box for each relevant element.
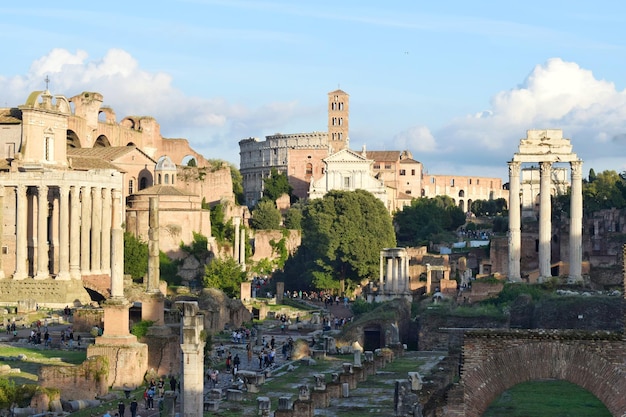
[569,160,583,282]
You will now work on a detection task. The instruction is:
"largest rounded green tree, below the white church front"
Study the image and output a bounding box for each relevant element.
[294,190,396,293]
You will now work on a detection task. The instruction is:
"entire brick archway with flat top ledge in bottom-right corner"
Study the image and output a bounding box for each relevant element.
[459,332,626,417]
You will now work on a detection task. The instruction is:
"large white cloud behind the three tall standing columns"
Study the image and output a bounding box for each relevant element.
[426,58,626,175]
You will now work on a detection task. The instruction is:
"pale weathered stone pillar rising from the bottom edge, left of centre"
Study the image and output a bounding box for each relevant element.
[176,301,206,417]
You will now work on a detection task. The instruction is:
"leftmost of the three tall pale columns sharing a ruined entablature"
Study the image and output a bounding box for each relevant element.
[508,161,522,282]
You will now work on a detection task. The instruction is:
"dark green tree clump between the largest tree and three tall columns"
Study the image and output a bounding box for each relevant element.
[394,196,465,246]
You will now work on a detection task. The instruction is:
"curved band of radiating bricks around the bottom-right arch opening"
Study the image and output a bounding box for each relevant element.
[463,341,626,417]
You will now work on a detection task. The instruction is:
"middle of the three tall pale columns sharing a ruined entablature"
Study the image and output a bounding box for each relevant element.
[539,161,552,282]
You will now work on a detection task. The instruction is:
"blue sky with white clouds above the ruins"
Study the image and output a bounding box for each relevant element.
[0,0,626,180]
